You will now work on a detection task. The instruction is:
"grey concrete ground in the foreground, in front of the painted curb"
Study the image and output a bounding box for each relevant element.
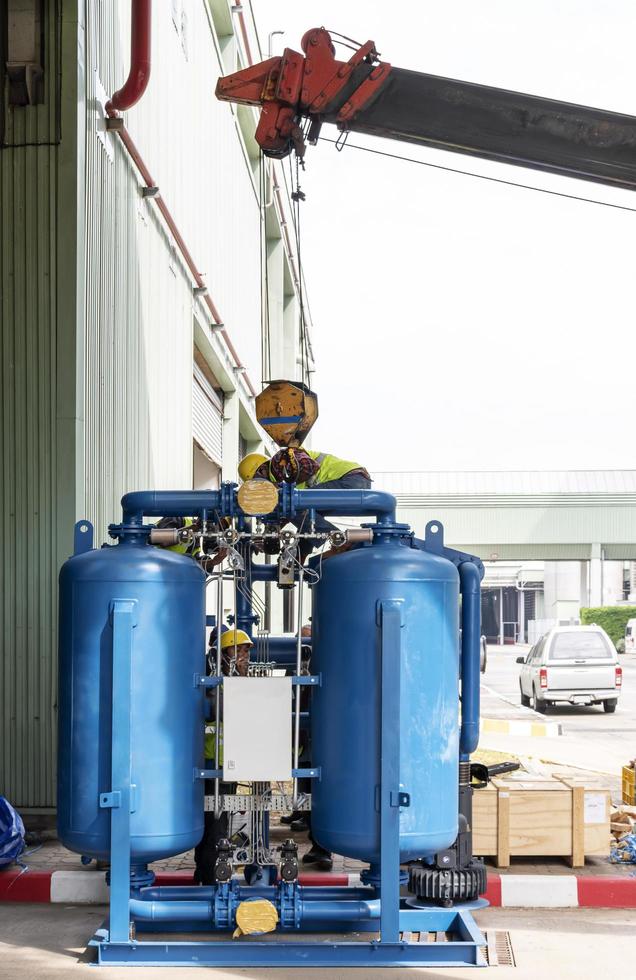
[0,904,636,980]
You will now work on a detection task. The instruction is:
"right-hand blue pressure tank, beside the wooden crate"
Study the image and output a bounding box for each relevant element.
[311,532,459,864]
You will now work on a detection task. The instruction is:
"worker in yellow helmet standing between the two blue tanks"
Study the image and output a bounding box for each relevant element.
[194,629,253,885]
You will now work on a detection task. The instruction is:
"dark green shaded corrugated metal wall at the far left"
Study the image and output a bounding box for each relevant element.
[0,2,61,804]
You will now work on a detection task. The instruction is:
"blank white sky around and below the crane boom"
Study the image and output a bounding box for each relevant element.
[253,0,636,471]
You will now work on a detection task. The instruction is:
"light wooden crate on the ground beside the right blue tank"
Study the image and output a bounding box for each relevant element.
[473,773,610,868]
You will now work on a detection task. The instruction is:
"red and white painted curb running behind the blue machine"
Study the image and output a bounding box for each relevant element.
[0,868,636,909]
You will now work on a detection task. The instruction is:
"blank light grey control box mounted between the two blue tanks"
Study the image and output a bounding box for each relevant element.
[223,677,292,783]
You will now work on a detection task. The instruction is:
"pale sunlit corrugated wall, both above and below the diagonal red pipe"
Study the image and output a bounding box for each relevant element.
[84,0,260,529]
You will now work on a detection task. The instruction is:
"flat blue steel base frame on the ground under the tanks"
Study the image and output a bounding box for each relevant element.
[89,904,486,969]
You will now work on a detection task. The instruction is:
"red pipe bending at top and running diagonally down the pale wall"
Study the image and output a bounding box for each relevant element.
[106,0,256,398]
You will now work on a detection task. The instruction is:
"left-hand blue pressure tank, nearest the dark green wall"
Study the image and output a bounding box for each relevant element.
[58,537,205,862]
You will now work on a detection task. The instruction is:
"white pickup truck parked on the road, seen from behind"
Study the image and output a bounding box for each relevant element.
[517,626,623,714]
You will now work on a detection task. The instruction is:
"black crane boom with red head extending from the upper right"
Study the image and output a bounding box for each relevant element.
[216,28,636,190]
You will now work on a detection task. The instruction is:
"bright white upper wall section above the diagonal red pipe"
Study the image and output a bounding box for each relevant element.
[119,0,260,385]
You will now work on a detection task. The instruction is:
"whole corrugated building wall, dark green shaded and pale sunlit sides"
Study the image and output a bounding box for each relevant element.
[0,0,306,807]
